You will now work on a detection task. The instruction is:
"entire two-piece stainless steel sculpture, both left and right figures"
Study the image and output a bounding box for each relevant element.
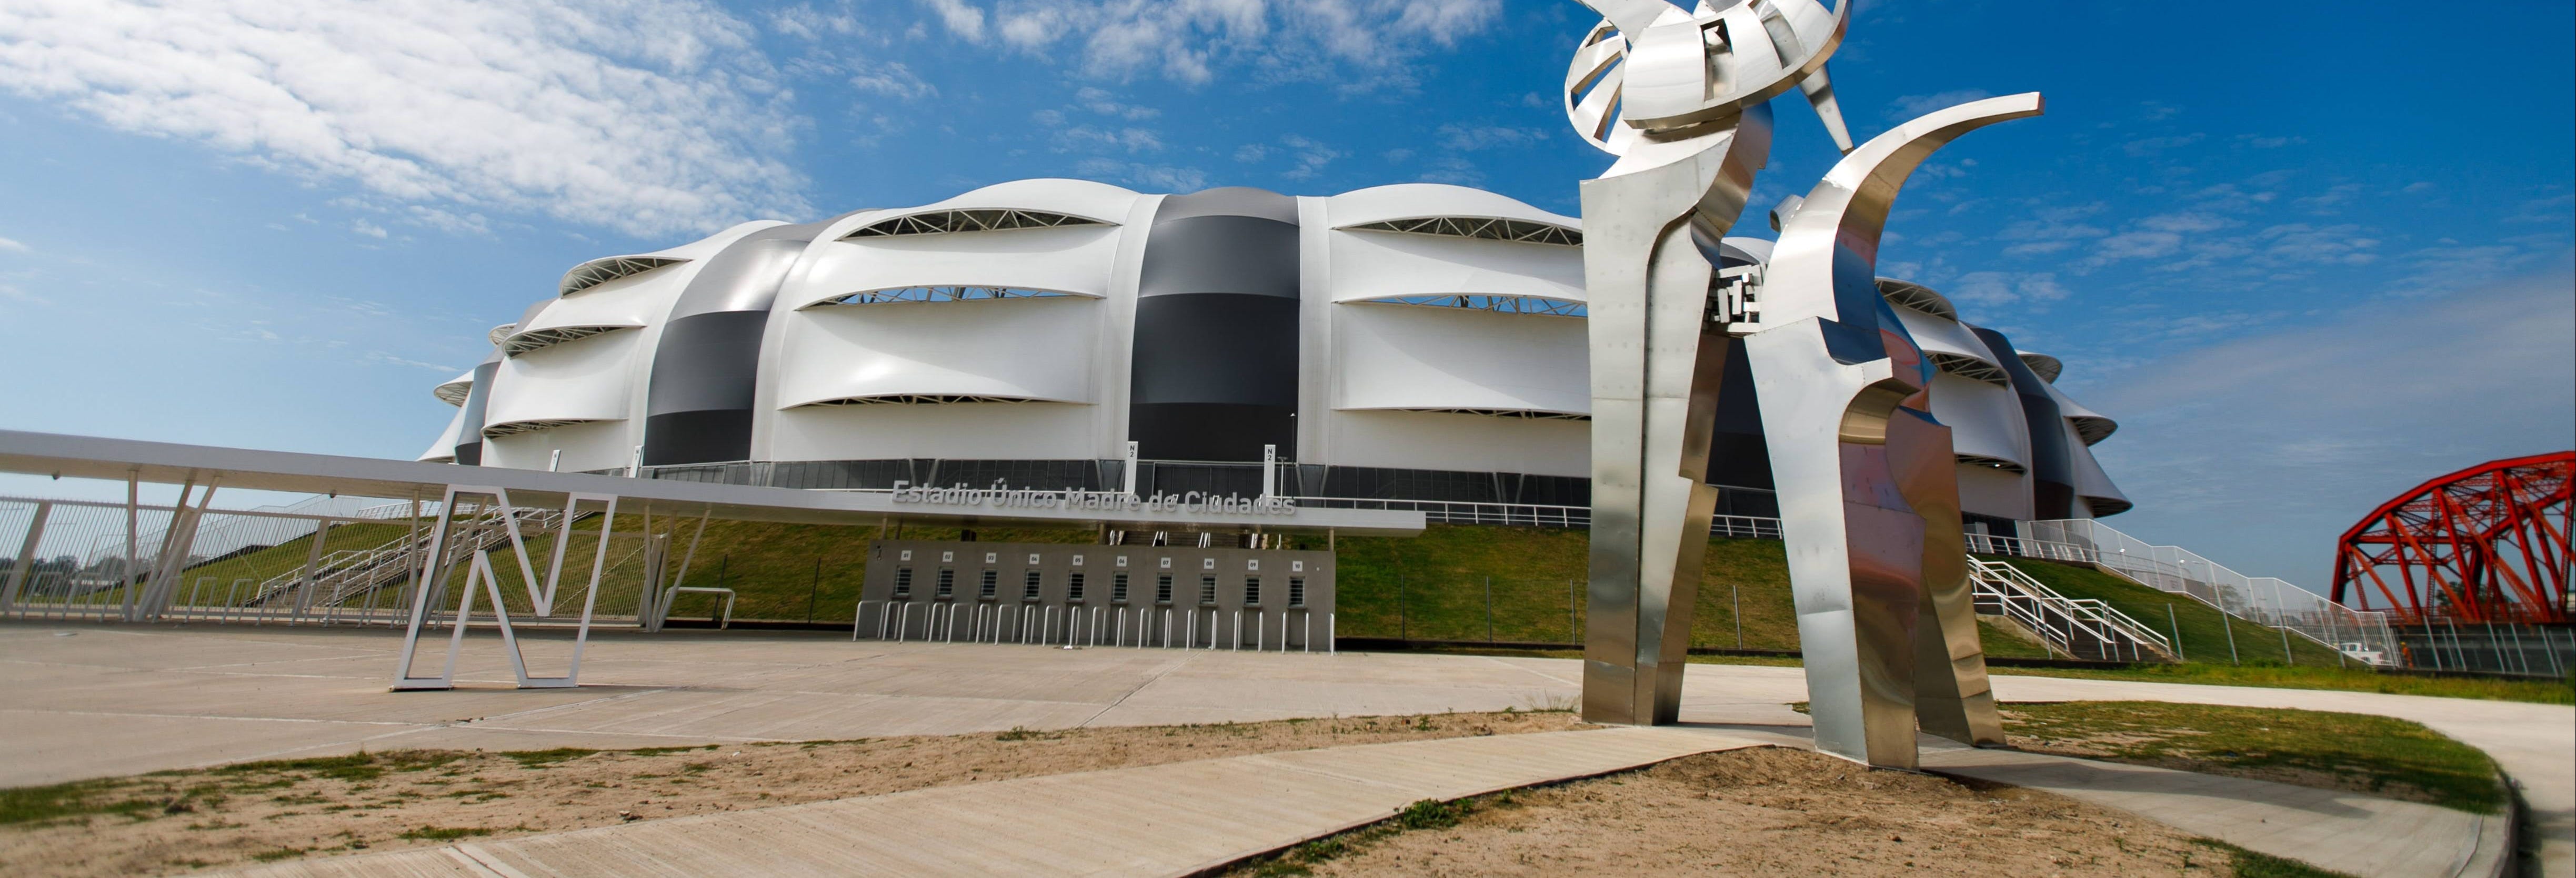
[1566,0,2040,768]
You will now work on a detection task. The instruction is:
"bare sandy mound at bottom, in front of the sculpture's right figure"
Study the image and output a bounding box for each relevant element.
[1267,746,2233,878]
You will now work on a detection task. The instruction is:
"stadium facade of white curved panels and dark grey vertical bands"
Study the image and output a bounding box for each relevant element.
[423,180,2128,533]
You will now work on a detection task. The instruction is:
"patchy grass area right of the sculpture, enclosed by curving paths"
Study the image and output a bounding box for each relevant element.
[2004,700,2507,814]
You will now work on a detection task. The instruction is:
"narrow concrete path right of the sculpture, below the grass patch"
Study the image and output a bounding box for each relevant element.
[1922,742,2512,878]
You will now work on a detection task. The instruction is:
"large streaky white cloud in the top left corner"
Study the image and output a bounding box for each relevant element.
[0,0,811,234]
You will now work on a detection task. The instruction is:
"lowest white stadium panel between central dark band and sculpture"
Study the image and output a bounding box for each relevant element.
[1301,412,1592,476]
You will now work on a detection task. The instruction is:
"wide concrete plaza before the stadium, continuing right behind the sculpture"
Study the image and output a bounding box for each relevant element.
[0,623,2576,878]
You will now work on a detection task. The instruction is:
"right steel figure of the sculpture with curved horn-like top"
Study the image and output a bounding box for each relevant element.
[1739,93,2040,768]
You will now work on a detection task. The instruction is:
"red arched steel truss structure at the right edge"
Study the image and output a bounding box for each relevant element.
[2334,451,2576,623]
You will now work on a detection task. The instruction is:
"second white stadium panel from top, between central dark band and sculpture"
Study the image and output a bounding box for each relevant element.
[1327,229,1589,301]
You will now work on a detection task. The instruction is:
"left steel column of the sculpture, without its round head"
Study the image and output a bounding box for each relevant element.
[1582,108,1770,723]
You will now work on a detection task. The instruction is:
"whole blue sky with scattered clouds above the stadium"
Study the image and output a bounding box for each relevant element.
[0,0,2576,587]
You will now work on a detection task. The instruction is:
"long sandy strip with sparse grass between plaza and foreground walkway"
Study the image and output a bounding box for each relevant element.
[0,713,1587,875]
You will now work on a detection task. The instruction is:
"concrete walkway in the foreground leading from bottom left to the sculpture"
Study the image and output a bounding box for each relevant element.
[239,726,1759,878]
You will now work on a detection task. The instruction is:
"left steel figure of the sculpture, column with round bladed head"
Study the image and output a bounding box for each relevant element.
[1566,0,1852,723]
